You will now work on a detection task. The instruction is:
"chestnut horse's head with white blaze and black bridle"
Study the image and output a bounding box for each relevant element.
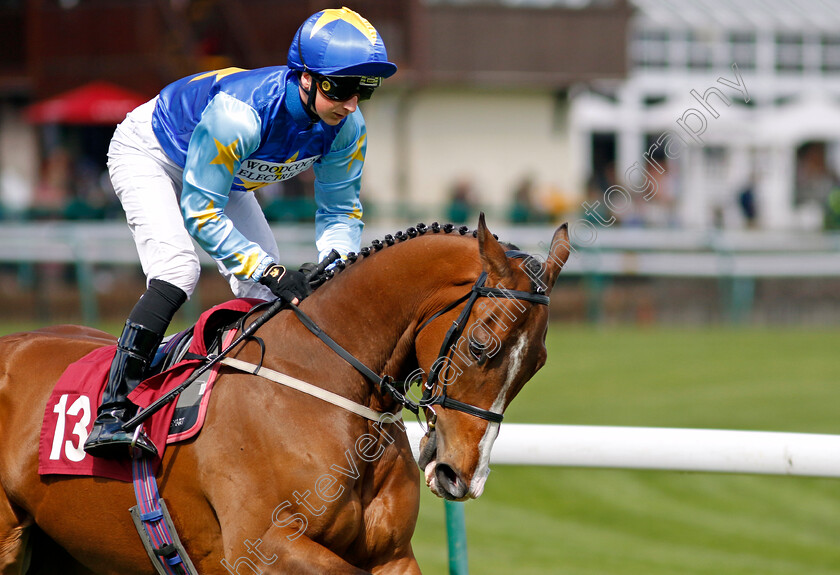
[416,215,569,500]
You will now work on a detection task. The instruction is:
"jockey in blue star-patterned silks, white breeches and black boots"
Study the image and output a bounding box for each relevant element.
[84,8,397,457]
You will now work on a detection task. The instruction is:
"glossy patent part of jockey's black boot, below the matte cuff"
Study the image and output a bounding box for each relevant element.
[85,320,163,459]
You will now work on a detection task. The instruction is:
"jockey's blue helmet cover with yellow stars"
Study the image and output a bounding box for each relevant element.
[288,8,397,78]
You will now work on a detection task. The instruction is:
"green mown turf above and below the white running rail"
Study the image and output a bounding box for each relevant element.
[414,325,840,575]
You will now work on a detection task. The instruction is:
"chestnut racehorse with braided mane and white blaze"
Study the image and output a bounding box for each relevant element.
[0,216,569,575]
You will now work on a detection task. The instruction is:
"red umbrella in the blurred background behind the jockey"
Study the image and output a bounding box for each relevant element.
[26,82,148,125]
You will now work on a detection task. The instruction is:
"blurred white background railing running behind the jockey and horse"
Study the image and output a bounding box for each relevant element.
[0,221,840,324]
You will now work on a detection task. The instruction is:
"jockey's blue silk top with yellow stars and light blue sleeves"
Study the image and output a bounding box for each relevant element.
[152,66,367,281]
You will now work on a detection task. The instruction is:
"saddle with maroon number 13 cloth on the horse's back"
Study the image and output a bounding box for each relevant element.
[38,298,265,481]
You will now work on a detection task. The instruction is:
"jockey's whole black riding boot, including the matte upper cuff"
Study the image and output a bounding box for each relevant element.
[84,279,187,458]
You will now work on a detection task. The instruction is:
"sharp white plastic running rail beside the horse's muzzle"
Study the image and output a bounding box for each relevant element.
[406,421,840,477]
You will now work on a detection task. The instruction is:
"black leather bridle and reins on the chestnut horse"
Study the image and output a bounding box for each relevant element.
[290,250,549,423]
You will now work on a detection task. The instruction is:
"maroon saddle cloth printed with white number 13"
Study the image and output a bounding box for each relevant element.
[38,298,263,481]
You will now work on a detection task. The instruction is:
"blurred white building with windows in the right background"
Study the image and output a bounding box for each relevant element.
[570,0,840,229]
